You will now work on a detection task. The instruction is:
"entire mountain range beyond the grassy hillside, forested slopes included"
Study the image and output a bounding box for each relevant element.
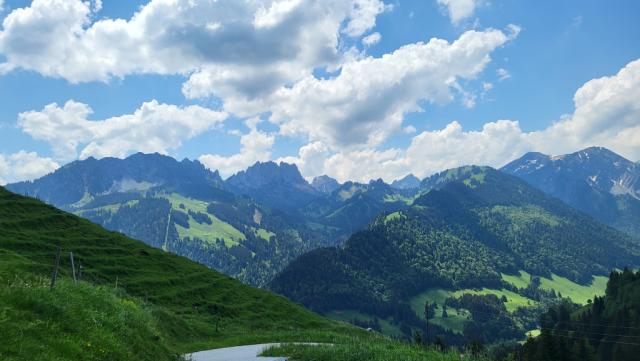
[7,148,640,343]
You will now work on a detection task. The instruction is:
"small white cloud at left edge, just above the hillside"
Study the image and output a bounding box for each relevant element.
[0,150,60,185]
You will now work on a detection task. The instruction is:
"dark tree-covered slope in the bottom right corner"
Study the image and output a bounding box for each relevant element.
[512,269,640,361]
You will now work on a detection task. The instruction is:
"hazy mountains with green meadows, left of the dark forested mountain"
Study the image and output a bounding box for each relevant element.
[7,153,410,285]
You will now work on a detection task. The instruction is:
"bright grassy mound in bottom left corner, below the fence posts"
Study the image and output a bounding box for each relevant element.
[0,277,179,361]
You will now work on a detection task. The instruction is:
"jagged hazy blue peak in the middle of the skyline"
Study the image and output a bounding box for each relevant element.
[226,162,321,211]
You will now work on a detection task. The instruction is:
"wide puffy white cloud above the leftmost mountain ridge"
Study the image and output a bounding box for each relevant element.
[18,100,227,160]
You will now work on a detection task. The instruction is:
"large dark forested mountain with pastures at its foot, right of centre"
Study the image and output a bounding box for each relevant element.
[271,167,640,342]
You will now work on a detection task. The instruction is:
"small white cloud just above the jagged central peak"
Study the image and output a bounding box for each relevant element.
[198,128,275,177]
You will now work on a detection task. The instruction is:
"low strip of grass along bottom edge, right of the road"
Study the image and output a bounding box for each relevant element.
[262,336,486,361]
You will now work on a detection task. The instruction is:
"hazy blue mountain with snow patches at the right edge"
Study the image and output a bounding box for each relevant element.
[502,147,640,237]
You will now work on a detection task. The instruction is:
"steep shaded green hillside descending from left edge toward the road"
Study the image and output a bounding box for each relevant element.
[0,188,353,360]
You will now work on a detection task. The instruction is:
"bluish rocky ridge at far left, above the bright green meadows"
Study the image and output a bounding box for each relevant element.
[7,153,232,210]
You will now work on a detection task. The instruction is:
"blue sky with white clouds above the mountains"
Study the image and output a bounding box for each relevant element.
[0,0,640,182]
